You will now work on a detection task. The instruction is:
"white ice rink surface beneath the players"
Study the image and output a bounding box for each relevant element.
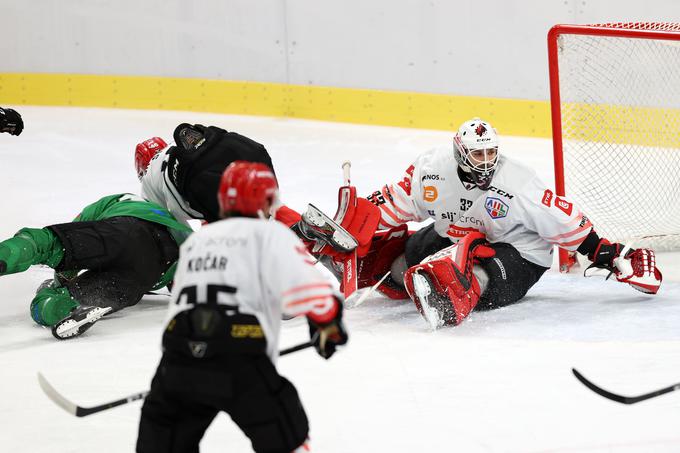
[0,107,680,453]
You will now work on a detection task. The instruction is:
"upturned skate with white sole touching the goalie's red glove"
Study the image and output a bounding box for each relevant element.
[298,204,359,254]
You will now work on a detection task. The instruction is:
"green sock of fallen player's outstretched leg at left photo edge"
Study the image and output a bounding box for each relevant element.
[0,228,64,275]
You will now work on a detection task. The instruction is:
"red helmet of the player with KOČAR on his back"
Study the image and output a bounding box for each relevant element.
[217,160,279,217]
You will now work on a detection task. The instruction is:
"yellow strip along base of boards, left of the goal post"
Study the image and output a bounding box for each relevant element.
[0,73,551,137]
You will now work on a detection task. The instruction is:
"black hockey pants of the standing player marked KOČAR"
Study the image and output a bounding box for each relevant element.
[137,317,309,453]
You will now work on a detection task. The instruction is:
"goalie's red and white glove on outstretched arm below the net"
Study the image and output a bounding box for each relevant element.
[577,230,663,294]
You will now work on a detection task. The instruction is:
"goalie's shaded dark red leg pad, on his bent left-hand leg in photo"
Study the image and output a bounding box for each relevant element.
[357,225,411,300]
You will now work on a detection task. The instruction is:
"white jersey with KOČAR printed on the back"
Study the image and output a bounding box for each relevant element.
[166,217,339,361]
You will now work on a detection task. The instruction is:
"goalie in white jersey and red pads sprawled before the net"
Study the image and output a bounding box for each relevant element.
[290,118,661,328]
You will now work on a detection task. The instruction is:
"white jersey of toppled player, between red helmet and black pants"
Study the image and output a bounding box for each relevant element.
[142,143,202,225]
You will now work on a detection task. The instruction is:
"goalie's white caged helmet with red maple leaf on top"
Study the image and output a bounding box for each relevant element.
[453,118,498,190]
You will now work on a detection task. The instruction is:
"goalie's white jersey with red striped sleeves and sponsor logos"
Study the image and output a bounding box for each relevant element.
[371,147,593,267]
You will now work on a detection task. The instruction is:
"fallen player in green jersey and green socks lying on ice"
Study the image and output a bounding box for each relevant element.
[0,194,191,339]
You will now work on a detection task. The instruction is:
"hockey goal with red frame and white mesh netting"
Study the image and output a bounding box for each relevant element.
[548,23,680,271]
